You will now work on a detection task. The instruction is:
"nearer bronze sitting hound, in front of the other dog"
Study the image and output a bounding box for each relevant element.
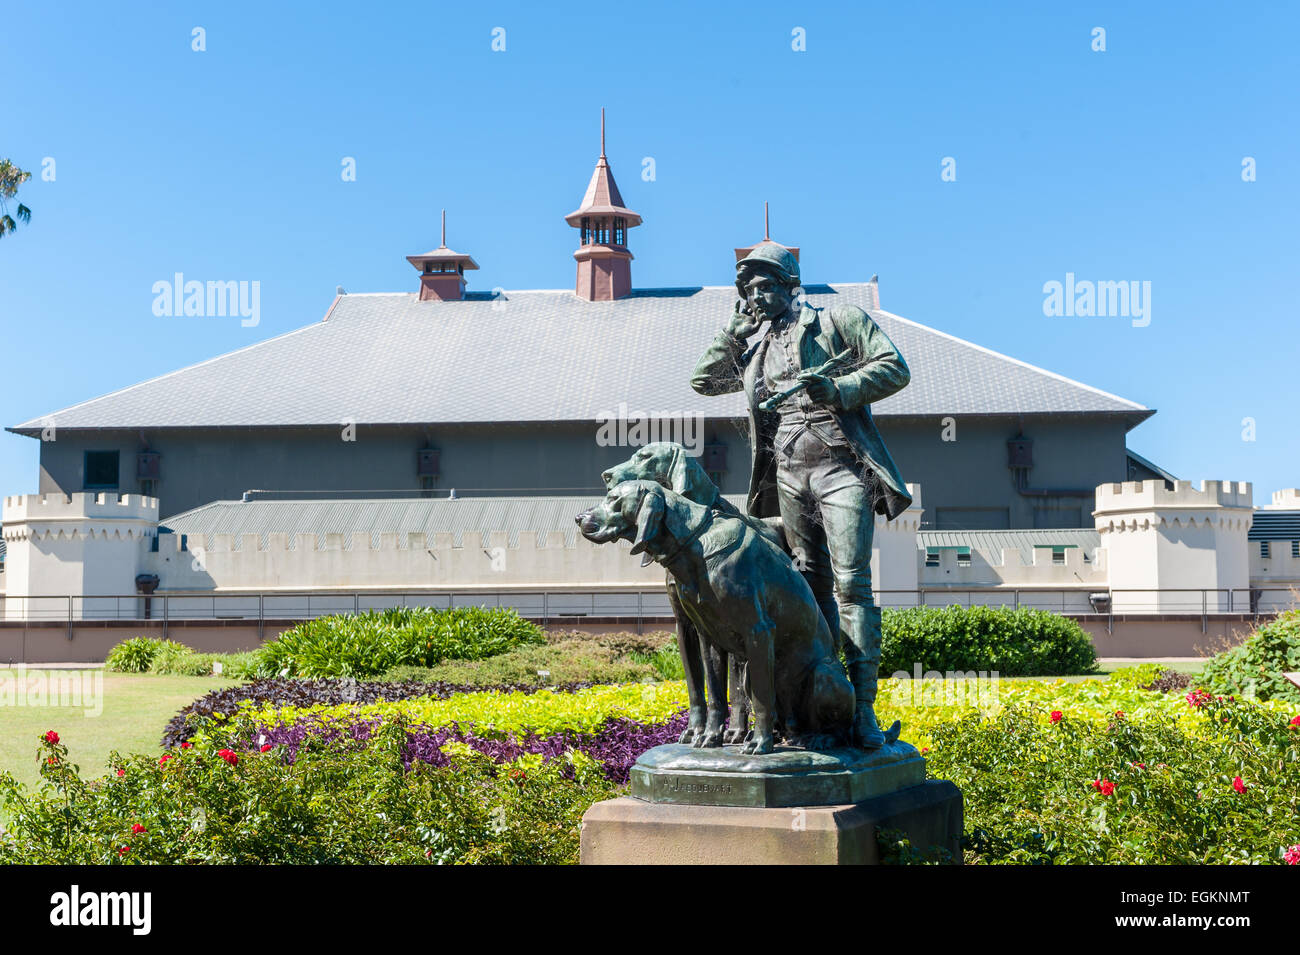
[575,481,854,754]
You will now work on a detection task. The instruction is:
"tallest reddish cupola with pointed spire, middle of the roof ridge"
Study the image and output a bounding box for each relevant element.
[564,109,641,301]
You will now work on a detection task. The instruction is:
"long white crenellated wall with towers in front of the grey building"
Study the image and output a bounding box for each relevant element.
[3,481,1300,617]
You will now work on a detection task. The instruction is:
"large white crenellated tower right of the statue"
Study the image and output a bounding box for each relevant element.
[1092,481,1253,612]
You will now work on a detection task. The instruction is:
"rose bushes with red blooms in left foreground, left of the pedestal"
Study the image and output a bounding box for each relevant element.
[0,722,618,865]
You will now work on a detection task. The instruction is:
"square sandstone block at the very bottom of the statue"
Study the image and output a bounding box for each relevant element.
[581,780,962,865]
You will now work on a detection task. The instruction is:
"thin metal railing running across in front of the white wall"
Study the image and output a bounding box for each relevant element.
[0,587,1296,637]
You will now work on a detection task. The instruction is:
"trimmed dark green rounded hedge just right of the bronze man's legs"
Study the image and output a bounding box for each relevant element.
[880,607,1097,677]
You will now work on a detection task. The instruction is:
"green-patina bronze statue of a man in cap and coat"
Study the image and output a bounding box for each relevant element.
[690,242,911,750]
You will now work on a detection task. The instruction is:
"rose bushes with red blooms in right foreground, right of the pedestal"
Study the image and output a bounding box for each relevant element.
[927,694,1300,865]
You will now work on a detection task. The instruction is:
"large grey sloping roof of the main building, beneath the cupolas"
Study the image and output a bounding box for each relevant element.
[10,283,1152,433]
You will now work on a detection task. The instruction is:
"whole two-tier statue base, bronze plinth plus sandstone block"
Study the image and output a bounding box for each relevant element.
[581,742,962,865]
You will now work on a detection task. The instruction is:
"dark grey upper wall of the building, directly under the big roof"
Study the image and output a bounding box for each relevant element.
[27,416,1126,529]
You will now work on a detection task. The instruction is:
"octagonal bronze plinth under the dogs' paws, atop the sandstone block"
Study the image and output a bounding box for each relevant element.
[632,741,926,809]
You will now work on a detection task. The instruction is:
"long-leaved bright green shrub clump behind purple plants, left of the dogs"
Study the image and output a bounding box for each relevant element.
[256,607,545,677]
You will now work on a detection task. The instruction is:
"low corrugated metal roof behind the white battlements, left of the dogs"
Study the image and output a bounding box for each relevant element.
[163,494,745,548]
